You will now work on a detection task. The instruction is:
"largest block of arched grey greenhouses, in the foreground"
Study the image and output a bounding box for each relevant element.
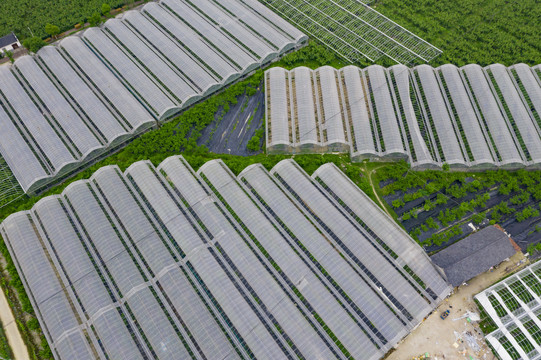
[0,156,451,360]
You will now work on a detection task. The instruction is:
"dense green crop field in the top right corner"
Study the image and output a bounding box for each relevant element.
[372,0,541,66]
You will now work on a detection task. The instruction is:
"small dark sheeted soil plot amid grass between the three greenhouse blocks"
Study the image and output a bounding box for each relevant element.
[197,90,265,156]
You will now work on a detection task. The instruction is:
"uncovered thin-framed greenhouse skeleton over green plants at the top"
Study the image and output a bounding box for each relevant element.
[260,0,441,65]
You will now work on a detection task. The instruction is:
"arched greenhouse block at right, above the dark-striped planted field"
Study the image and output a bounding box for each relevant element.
[265,64,541,169]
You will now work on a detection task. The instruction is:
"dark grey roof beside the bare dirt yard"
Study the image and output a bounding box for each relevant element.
[431,226,516,286]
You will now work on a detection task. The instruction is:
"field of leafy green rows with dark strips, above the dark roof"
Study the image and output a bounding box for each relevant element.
[376,164,541,252]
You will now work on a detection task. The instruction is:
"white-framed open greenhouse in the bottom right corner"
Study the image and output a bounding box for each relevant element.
[475,262,541,360]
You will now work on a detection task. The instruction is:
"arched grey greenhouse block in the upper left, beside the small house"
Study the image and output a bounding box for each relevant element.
[0,0,307,193]
